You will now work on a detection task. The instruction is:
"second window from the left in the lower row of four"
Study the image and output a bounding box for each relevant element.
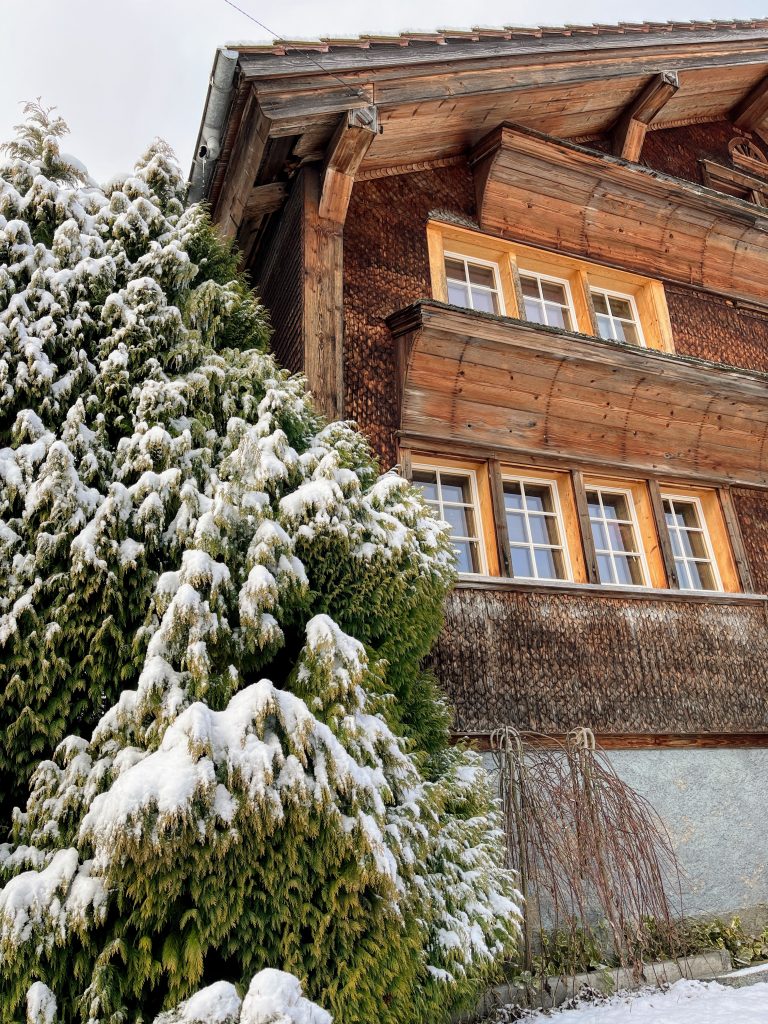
[503,478,570,580]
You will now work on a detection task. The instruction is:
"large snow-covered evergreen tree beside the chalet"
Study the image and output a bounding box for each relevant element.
[0,106,519,1024]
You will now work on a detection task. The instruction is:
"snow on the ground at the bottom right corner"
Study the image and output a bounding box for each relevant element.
[525,981,768,1024]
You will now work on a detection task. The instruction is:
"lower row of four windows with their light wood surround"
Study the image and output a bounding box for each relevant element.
[403,450,752,594]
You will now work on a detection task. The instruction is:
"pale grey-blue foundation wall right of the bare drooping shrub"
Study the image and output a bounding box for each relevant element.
[485,750,768,927]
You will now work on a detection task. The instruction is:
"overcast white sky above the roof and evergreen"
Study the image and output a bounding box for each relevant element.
[0,0,768,180]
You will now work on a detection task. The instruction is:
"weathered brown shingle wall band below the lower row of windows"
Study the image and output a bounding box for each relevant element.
[430,587,768,735]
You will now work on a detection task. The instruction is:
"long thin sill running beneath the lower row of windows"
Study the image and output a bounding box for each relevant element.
[456,573,768,604]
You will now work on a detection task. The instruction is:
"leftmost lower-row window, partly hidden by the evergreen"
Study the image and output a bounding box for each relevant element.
[412,466,485,572]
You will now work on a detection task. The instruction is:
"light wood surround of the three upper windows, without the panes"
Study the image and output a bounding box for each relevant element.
[427,220,675,352]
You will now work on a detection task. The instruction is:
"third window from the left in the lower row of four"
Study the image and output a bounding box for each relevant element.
[587,487,647,587]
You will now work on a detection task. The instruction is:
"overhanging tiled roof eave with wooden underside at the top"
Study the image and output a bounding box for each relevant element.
[192,20,768,243]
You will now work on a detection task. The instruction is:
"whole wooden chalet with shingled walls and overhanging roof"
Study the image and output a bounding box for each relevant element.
[191,20,768,910]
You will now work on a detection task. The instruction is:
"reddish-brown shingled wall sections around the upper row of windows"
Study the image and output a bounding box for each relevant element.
[344,124,768,467]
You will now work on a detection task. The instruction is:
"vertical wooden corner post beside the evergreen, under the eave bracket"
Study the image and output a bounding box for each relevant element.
[301,166,344,420]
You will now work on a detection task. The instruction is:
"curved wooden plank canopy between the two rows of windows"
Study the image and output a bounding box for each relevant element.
[388,301,768,486]
